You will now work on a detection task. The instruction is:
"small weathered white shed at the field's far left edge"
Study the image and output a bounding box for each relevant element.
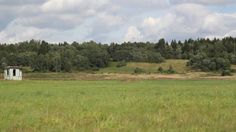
[4,66,22,80]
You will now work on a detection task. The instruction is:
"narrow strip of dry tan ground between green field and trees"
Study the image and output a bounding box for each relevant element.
[0,72,236,81]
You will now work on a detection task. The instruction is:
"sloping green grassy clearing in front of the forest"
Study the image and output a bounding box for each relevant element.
[99,60,189,73]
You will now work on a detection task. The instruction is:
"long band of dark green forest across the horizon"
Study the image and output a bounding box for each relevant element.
[0,37,236,72]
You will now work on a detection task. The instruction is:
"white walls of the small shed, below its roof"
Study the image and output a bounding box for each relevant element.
[4,69,22,80]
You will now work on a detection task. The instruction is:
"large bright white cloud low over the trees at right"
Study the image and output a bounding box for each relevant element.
[123,4,236,41]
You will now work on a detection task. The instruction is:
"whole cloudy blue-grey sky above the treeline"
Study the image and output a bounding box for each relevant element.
[0,0,236,43]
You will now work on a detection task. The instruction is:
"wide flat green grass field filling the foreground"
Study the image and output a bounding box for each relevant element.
[0,80,236,132]
